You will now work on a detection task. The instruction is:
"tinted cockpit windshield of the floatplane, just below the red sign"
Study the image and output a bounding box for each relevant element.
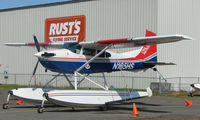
[62,42,81,54]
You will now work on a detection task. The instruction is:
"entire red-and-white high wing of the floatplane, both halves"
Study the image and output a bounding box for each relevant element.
[5,35,192,50]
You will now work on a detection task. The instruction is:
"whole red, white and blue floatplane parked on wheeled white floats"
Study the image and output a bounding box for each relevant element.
[3,30,191,113]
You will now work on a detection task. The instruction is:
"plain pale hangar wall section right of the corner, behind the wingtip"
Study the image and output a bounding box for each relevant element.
[158,0,200,77]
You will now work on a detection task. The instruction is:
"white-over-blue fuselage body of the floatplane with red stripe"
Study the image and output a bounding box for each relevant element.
[37,49,157,74]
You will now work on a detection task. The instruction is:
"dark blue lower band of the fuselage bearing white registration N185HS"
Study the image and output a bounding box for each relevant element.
[40,56,157,74]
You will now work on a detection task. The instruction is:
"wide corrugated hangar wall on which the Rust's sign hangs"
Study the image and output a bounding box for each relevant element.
[0,0,158,87]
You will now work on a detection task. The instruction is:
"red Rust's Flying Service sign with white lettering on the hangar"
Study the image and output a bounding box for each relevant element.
[45,15,86,43]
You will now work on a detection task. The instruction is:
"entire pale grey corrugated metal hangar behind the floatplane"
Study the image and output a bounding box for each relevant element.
[0,0,200,89]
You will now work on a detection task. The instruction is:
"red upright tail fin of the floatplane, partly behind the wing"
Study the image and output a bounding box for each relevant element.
[136,30,157,62]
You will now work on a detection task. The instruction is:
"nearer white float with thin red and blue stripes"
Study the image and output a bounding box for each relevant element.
[44,88,152,109]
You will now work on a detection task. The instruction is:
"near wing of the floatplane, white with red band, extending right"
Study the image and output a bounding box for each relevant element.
[79,34,192,49]
